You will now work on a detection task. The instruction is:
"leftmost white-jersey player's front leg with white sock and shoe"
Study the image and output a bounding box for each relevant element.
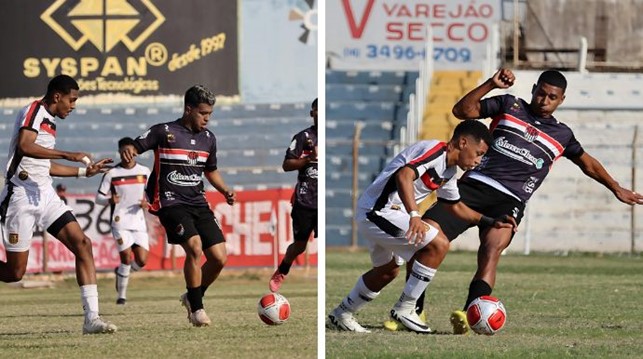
[55,221,117,334]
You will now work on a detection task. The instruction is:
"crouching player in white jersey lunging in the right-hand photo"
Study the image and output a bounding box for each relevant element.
[328,121,515,333]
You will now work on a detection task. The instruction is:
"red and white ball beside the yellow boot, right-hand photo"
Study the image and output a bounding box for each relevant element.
[467,295,507,335]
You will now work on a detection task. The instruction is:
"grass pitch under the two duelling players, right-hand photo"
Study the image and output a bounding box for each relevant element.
[326,252,643,358]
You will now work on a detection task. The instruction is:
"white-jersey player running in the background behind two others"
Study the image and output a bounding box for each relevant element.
[96,137,150,305]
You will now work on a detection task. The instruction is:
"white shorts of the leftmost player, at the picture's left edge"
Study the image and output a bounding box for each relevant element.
[0,186,72,252]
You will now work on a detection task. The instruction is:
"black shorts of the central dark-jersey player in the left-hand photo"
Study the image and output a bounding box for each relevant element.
[158,204,225,249]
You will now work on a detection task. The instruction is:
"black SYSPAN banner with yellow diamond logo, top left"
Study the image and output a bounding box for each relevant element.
[0,0,239,98]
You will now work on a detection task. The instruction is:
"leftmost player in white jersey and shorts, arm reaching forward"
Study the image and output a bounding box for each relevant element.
[0,75,117,334]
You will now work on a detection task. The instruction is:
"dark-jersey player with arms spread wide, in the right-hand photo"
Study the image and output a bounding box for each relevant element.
[416,69,643,334]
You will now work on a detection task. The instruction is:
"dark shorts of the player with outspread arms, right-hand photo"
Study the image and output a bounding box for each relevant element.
[422,178,525,241]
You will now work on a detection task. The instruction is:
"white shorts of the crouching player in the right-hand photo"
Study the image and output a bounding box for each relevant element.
[357,208,438,267]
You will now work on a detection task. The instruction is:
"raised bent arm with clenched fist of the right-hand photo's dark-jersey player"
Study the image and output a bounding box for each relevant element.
[452,69,516,120]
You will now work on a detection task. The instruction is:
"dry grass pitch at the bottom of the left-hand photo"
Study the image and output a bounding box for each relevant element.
[0,269,317,359]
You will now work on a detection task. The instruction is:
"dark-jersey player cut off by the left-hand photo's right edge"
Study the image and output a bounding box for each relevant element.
[268,99,317,292]
